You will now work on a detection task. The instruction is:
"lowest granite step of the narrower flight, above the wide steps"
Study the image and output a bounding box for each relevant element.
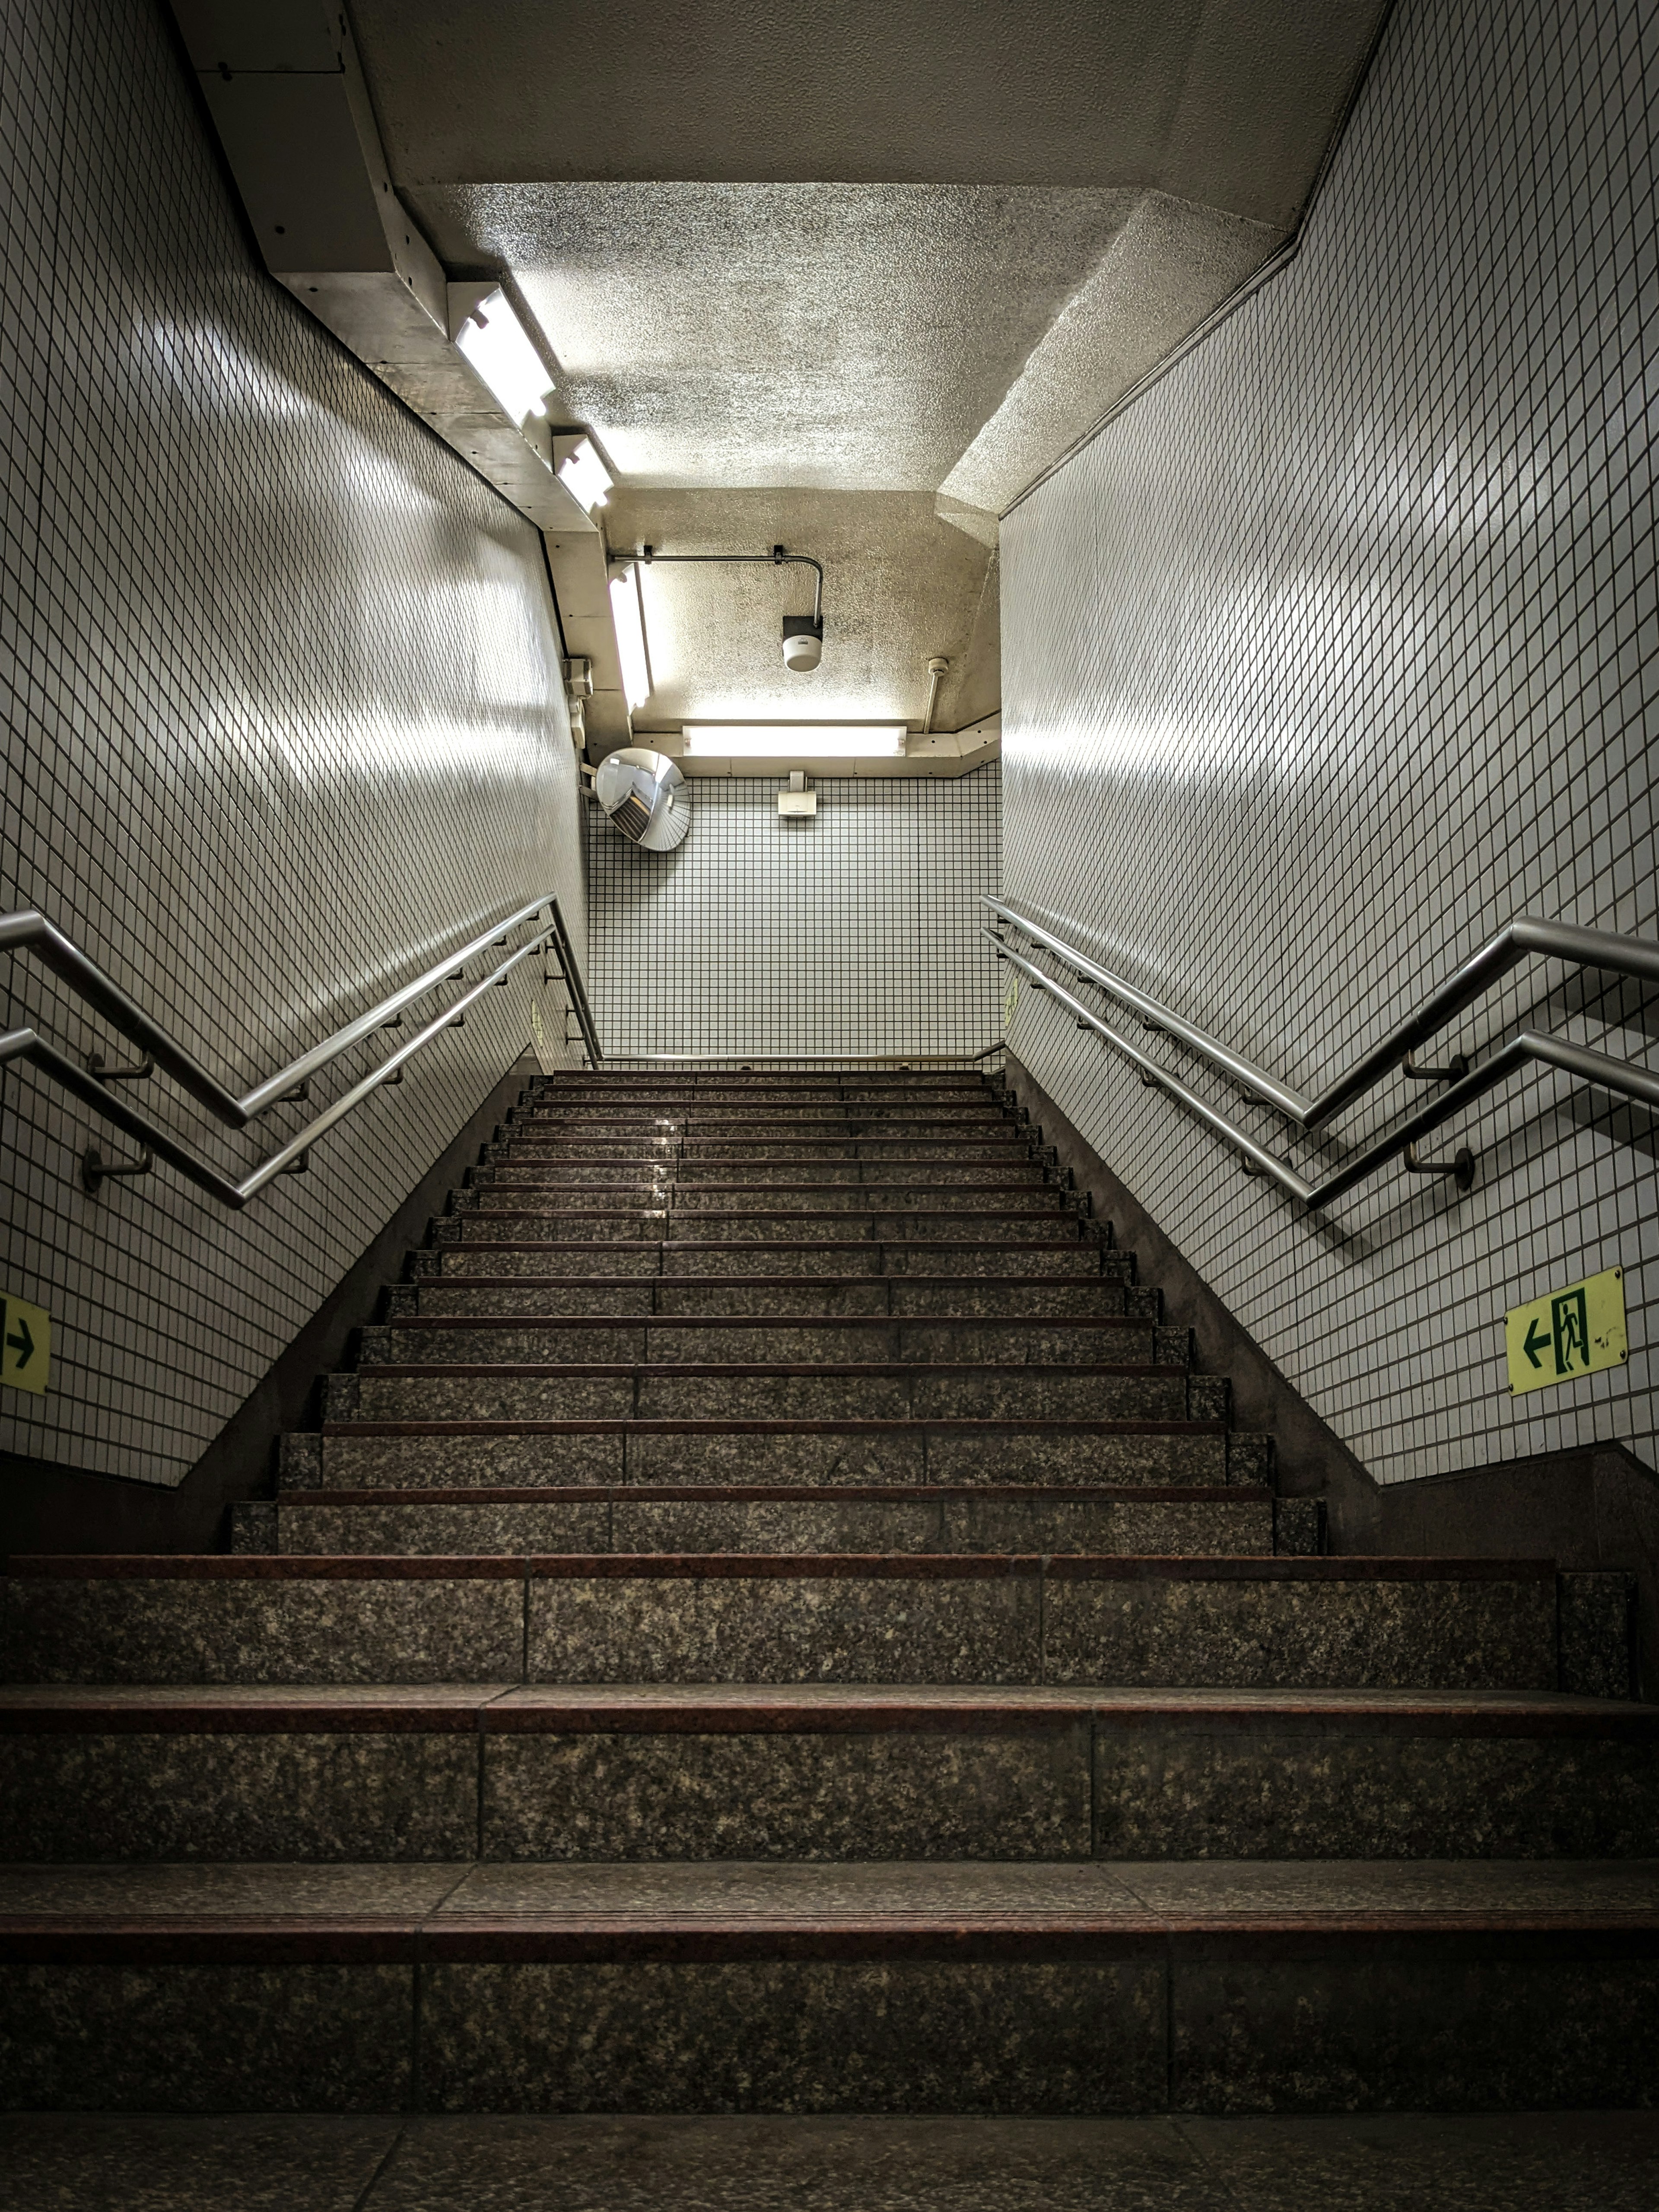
[246,1484,1287,1557]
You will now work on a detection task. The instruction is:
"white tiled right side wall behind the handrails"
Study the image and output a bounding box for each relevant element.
[1002,0,1659,1482]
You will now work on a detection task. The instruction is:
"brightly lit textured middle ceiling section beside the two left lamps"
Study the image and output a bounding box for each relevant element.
[409,184,1135,491]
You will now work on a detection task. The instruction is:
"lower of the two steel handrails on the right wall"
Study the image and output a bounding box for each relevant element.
[980,925,1659,1208]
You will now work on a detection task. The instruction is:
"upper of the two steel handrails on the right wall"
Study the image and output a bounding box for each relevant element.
[980,893,1659,1128]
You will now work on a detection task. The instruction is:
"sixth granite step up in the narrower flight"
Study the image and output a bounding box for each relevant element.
[431,1247,1135,1283]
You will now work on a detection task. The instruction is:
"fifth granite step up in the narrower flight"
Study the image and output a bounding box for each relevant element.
[400,1254,1159,1323]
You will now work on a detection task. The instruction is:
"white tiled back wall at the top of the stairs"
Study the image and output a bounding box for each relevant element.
[588,761,1002,1062]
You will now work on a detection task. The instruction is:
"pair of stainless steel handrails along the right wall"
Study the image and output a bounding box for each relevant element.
[980,898,1659,1208]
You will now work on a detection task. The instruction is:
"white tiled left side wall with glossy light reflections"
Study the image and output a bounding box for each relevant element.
[0,0,584,1482]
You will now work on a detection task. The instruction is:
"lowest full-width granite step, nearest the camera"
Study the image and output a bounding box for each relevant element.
[0,1858,1659,2114]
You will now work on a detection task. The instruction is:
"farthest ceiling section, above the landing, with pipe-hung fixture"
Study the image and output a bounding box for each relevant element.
[606,491,995,730]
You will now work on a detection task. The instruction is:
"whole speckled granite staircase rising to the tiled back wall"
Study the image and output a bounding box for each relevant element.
[0,1073,1659,2115]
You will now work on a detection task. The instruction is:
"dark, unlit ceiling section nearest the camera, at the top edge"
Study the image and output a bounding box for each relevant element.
[352,0,1380,223]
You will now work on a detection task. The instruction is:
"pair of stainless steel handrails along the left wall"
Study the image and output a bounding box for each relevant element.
[0,893,604,1210]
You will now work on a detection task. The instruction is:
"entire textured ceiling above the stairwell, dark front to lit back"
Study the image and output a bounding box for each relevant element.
[352,0,1387,728]
